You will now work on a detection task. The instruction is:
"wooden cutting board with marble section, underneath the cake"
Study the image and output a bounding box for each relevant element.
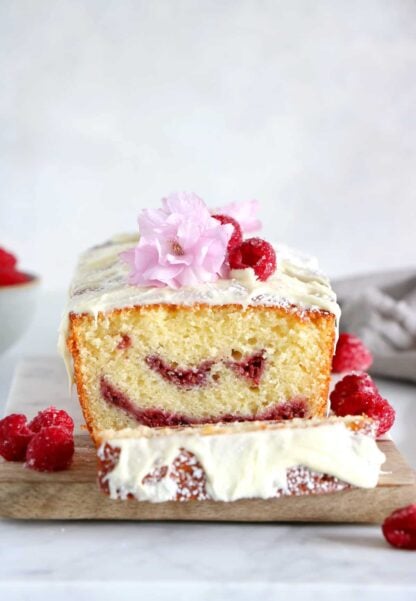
[0,358,416,523]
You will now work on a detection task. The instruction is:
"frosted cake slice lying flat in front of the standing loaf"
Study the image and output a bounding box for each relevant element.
[97,416,385,502]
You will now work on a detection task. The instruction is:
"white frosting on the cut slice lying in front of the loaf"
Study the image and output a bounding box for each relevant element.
[98,418,385,502]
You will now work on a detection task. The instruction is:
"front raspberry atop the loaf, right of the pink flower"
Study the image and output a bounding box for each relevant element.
[229,238,276,282]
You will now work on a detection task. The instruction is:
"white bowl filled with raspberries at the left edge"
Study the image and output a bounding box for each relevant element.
[0,247,39,353]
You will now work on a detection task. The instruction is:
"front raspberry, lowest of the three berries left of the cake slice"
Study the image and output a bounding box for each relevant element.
[26,426,74,472]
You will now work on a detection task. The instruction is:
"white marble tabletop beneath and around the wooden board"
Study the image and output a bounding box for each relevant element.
[0,293,416,601]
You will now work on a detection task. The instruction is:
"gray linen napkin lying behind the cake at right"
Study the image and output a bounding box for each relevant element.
[332,270,416,381]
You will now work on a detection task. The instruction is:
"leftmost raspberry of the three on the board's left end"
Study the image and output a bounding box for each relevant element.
[0,413,33,461]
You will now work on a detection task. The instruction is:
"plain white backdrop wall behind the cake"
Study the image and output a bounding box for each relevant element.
[0,0,416,289]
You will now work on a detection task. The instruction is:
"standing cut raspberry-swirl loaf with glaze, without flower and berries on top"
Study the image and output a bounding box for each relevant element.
[62,238,339,440]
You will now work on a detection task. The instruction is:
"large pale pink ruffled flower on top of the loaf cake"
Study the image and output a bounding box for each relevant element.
[121,192,233,288]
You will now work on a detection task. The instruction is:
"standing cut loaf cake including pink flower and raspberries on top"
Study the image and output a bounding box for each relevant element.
[60,194,339,440]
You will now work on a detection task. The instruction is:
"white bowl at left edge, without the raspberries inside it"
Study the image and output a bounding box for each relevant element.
[0,273,40,353]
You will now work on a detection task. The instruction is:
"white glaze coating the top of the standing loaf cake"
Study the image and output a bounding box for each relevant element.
[62,234,340,321]
